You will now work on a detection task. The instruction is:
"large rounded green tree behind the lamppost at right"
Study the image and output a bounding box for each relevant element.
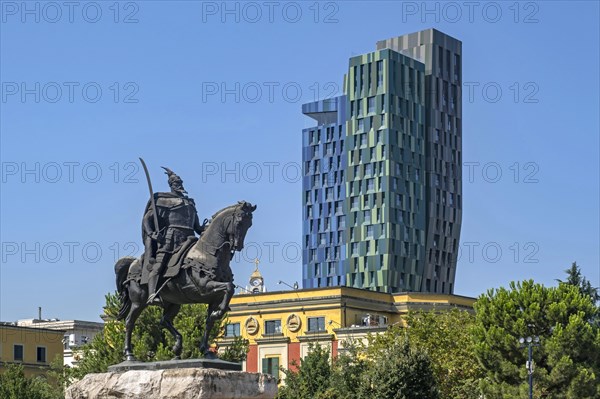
[473,280,600,399]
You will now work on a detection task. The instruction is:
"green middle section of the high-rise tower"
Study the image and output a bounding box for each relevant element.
[345,49,426,292]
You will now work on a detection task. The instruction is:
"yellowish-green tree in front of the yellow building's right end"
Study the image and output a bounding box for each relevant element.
[404,308,483,399]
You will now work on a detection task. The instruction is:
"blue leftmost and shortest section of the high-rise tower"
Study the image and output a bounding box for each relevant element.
[302,96,347,288]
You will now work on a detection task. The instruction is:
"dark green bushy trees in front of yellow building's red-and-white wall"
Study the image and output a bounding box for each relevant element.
[279,332,439,399]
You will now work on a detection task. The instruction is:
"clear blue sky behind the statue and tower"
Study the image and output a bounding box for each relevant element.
[0,1,600,321]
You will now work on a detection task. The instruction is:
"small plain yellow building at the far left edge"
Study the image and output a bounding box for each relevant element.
[0,323,65,377]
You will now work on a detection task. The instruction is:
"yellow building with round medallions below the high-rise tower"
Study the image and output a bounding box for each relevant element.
[219,287,475,375]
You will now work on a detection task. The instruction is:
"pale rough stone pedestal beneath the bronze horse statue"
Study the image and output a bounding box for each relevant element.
[66,367,277,399]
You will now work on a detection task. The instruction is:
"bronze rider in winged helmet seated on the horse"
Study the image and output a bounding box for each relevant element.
[142,167,205,304]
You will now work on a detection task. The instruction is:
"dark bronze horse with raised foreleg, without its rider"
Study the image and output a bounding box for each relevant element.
[115,201,256,361]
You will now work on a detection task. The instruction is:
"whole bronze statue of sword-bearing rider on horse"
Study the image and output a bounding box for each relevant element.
[115,159,256,361]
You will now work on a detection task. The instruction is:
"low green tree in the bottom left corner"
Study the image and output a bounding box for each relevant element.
[0,364,62,399]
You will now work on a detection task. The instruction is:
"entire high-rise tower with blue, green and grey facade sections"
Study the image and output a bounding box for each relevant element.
[303,29,462,293]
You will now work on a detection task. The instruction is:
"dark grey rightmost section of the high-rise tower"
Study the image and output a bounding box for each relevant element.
[377,29,462,294]
